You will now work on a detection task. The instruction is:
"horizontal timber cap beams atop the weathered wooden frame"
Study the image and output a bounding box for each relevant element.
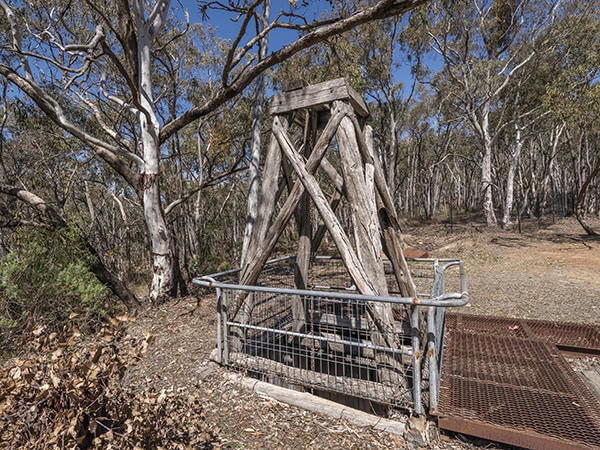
[270,78,369,117]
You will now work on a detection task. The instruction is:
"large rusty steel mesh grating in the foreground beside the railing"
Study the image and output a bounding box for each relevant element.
[437,328,600,448]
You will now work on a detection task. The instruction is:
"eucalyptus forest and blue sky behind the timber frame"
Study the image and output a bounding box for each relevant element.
[0,0,600,343]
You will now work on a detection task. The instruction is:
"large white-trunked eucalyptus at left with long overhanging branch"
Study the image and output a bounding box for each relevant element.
[0,0,432,301]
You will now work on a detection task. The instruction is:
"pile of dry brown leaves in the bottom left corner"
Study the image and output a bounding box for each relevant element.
[0,317,217,449]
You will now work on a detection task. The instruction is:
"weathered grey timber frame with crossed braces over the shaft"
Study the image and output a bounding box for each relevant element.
[230,78,424,376]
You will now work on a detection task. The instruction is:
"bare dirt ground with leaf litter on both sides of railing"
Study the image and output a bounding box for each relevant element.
[127,219,600,449]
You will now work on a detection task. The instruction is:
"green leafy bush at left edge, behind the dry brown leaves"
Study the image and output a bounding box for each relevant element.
[0,228,111,346]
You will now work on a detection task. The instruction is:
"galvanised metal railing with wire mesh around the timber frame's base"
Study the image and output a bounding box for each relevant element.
[193,257,468,414]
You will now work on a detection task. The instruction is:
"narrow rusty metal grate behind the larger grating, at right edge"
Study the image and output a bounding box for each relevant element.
[446,314,600,355]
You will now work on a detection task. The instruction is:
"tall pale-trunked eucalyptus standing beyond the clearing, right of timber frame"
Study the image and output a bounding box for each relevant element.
[411,0,561,225]
